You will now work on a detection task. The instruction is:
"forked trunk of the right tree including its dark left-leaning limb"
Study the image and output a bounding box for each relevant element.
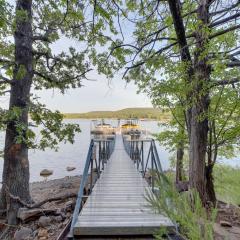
[168,0,213,204]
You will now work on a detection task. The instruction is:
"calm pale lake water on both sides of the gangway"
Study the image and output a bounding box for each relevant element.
[0,119,240,182]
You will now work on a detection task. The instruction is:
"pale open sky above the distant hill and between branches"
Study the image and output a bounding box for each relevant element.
[0,0,152,113]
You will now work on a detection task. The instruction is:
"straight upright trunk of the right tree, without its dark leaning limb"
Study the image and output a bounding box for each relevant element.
[189,0,210,205]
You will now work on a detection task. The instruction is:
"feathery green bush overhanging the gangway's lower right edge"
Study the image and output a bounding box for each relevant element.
[147,175,217,240]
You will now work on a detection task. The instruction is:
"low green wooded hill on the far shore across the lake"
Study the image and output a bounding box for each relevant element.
[64,108,170,120]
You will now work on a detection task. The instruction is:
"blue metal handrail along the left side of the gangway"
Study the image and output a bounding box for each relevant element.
[68,137,115,239]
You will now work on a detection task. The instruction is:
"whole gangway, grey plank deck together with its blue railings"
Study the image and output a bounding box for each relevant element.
[71,134,175,239]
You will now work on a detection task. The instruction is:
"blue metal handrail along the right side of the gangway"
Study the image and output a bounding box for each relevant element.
[123,135,163,192]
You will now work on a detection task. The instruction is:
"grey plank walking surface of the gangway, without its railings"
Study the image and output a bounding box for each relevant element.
[73,135,174,237]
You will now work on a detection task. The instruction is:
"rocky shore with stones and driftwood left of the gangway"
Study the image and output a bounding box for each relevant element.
[0,176,81,240]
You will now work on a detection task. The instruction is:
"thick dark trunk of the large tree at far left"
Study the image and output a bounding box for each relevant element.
[1,0,33,224]
